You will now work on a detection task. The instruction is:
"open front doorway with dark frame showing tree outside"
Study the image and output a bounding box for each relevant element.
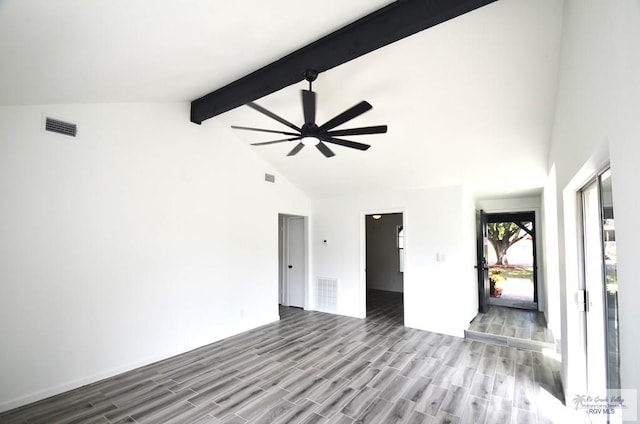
[477,211,538,312]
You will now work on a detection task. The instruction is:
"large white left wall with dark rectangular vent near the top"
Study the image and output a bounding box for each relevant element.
[0,103,310,411]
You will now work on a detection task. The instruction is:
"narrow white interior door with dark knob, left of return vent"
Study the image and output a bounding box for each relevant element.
[284,216,306,308]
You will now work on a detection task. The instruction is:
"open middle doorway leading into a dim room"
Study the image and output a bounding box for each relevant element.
[365,213,405,325]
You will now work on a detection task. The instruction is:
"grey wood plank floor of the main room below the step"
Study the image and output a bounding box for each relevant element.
[0,295,576,424]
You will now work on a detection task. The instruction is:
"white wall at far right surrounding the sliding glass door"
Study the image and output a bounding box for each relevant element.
[545,0,640,406]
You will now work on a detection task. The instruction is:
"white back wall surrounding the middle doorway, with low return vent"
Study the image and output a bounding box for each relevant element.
[311,187,478,336]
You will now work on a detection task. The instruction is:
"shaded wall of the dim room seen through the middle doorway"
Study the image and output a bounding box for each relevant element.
[366,214,403,292]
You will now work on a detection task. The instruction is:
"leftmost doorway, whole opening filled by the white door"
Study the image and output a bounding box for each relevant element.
[278,214,308,309]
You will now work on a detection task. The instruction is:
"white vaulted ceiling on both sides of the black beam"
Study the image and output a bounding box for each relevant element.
[0,0,562,197]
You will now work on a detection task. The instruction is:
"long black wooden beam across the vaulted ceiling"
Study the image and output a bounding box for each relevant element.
[191,0,497,124]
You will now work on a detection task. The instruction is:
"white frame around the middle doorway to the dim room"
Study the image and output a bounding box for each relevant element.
[358,208,410,319]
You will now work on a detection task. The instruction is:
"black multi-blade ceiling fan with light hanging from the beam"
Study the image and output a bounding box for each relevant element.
[231,70,387,158]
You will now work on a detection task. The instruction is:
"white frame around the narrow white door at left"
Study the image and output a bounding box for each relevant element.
[278,213,310,309]
